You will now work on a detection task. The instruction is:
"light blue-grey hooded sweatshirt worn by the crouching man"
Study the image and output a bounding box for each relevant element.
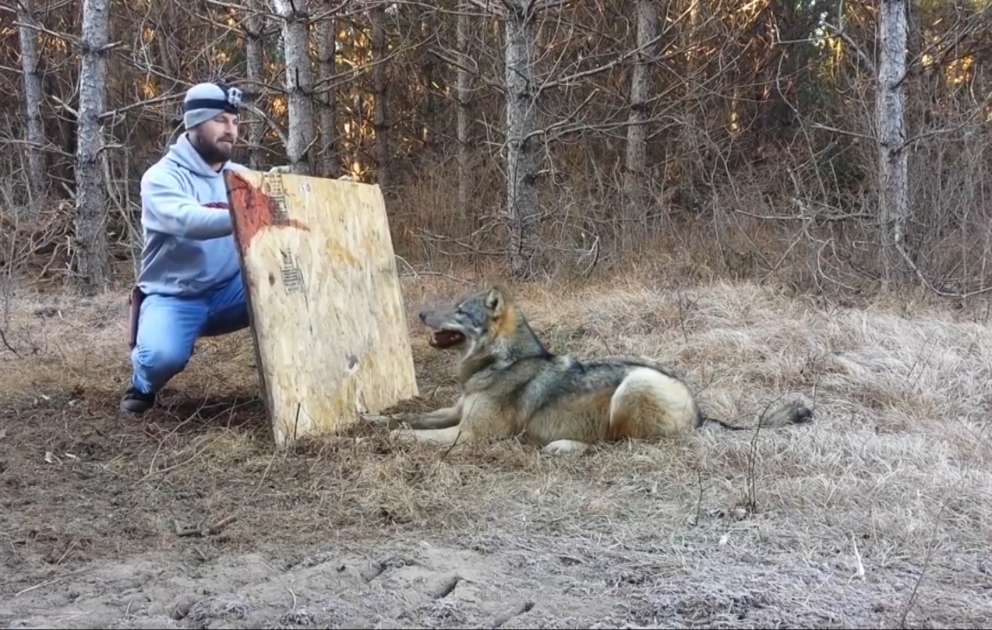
[138,133,248,296]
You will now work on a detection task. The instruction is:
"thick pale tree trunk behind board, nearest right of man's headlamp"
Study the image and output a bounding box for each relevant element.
[272,0,314,175]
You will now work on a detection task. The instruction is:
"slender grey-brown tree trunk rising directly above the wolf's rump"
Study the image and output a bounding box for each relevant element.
[624,0,658,222]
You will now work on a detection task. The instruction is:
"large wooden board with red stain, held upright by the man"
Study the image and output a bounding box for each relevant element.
[225,171,418,444]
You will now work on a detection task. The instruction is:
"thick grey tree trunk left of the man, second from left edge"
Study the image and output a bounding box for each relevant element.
[75,0,110,292]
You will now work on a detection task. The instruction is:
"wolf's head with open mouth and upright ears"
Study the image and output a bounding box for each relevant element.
[420,285,547,368]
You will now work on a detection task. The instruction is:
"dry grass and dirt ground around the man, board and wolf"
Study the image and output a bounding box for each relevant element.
[0,277,992,628]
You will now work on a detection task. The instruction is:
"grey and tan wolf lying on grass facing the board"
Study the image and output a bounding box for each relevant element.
[360,284,813,455]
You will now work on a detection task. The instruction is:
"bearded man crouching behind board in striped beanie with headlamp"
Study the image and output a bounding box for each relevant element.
[121,83,249,413]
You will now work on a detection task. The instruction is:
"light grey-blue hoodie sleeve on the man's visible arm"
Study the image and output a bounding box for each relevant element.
[141,169,232,241]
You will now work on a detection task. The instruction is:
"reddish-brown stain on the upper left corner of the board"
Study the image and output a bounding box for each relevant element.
[224,171,310,251]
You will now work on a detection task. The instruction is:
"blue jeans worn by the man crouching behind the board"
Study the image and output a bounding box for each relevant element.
[131,271,249,394]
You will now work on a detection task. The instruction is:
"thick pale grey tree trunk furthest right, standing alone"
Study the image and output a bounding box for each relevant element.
[876,0,909,285]
